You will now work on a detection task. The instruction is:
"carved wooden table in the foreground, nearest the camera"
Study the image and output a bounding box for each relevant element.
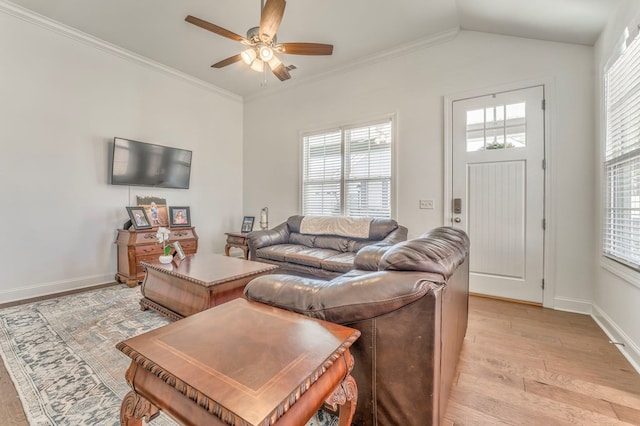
[116,299,360,426]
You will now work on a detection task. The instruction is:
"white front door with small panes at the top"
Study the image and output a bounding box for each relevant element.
[451,86,544,303]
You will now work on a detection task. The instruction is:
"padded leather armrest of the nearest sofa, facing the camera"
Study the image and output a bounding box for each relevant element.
[244,271,444,324]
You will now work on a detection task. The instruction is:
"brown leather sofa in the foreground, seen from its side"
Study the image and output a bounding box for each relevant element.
[245,227,469,426]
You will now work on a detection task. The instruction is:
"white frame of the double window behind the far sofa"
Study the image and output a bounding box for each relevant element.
[298,114,398,219]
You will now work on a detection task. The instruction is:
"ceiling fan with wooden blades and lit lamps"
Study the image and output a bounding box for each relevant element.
[185,0,333,81]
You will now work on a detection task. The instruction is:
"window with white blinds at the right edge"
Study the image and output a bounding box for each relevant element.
[603,30,640,270]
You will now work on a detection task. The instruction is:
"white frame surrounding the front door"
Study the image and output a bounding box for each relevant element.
[442,78,557,308]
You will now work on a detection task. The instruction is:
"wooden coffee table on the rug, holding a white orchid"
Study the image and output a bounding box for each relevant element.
[140,253,278,320]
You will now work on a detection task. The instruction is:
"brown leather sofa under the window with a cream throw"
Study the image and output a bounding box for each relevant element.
[247,216,407,278]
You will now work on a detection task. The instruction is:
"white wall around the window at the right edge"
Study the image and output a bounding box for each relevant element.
[593,0,640,372]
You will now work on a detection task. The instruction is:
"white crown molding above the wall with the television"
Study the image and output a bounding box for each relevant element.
[0,0,242,102]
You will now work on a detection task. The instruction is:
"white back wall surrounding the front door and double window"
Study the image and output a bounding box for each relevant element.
[243,31,595,311]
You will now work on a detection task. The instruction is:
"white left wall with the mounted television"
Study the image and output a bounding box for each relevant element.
[0,12,242,303]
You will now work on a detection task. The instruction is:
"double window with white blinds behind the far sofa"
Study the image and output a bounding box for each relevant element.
[302,119,393,218]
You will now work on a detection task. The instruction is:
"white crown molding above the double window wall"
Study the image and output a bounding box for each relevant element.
[244,27,460,102]
